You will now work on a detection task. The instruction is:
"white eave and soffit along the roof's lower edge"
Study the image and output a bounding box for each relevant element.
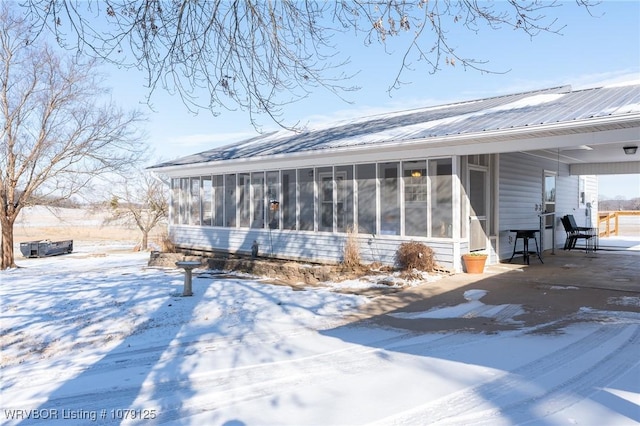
[152,113,640,176]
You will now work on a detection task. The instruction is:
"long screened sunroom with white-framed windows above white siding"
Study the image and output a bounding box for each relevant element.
[170,156,472,270]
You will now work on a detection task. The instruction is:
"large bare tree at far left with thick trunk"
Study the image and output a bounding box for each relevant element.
[0,3,146,269]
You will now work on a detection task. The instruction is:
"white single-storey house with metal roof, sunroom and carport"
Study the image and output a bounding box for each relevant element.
[151,83,640,271]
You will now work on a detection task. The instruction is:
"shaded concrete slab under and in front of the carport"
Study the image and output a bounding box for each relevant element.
[355,236,640,333]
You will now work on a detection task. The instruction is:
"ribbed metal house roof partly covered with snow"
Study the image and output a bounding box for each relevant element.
[151,83,640,169]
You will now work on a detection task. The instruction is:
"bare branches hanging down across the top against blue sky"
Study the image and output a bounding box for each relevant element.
[22,0,596,128]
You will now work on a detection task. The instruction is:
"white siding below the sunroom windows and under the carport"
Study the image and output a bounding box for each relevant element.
[170,153,597,271]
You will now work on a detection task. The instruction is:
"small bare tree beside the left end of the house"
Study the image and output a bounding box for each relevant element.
[106,173,169,250]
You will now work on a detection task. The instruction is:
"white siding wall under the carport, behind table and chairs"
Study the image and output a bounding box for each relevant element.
[498,153,597,260]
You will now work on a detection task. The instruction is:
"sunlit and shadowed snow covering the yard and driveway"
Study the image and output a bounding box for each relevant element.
[0,246,640,426]
